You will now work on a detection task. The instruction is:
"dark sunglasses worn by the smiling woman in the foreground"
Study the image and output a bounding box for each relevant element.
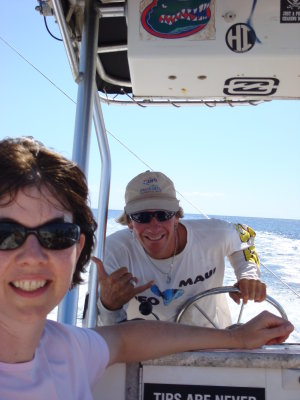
[0,222,80,250]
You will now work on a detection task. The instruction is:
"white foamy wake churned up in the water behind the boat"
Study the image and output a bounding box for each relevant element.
[49,217,300,343]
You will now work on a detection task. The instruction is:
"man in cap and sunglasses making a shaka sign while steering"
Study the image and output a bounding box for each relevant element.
[98,171,266,328]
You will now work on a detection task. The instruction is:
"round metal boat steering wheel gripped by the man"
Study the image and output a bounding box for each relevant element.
[176,286,288,329]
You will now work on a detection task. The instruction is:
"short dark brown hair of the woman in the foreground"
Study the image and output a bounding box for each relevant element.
[0,137,97,287]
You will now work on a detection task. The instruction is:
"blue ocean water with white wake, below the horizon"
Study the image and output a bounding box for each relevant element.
[52,210,300,343]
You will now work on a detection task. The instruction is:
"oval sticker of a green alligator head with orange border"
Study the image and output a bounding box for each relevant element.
[141,0,211,39]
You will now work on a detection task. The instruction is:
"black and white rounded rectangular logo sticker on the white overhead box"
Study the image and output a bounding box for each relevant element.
[223,77,279,96]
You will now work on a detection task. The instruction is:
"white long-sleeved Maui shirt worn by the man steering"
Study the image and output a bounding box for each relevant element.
[98,219,260,327]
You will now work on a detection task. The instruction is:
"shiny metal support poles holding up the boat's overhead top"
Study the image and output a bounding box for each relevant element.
[53,0,111,327]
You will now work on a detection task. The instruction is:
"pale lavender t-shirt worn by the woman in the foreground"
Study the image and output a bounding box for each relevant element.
[0,320,109,400]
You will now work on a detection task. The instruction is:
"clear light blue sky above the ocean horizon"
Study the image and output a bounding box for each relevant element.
[0,0,300,219]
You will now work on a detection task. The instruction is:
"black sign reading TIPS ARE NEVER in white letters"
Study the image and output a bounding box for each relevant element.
[143,383,266,400]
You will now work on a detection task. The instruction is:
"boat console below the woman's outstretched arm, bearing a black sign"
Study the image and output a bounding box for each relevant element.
[94,343,300,400]
